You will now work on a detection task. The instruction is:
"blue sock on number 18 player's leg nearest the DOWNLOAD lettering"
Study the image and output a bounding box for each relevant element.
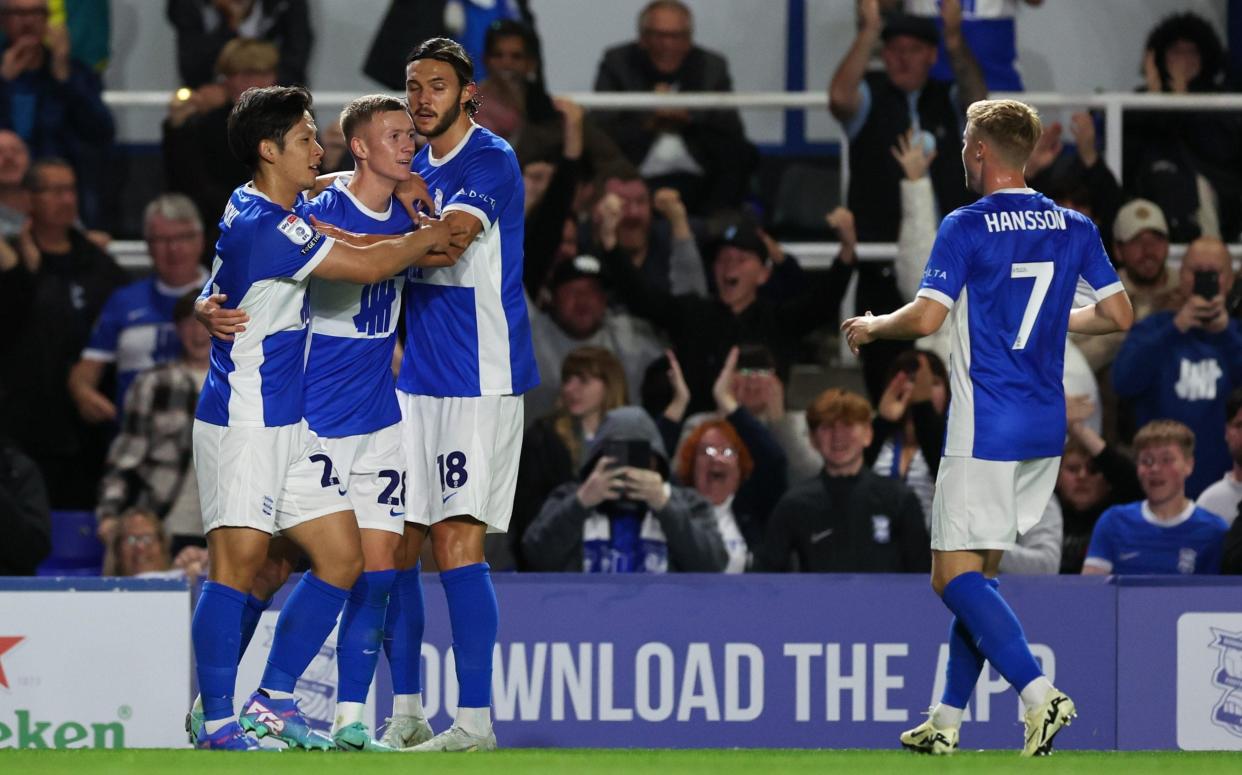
[440,563,501,708]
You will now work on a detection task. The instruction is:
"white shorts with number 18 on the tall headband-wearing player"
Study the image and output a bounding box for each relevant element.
[397,391,523,533]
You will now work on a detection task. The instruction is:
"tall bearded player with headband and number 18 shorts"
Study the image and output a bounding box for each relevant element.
[385,39,539,750]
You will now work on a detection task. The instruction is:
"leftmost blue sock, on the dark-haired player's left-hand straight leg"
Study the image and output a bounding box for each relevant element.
[190,581,246,722]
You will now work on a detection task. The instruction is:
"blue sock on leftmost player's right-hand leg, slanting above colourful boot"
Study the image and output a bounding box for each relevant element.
[260,571,349,694]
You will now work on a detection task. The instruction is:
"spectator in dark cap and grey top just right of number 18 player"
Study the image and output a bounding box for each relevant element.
[525,256,664,417]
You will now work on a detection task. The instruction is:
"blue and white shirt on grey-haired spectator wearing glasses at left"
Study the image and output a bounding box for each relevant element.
[82,274,204,411]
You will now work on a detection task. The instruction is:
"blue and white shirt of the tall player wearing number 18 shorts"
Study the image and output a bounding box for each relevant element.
[396,124,539,397]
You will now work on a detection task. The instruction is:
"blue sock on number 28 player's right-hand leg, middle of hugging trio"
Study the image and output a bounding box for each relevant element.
[337,570,396,703]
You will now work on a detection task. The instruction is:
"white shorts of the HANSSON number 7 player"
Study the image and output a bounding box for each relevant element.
[932,456,1061,551]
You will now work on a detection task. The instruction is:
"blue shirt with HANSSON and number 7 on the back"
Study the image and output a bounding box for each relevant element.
[918,189,1123,461]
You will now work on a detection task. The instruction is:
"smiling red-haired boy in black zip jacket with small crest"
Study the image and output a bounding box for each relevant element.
[755,388,932,573]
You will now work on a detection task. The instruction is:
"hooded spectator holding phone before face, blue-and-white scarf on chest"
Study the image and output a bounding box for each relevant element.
[522,406,729,573]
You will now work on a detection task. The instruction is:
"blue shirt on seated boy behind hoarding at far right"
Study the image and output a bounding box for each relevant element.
[1084,501,1228,574]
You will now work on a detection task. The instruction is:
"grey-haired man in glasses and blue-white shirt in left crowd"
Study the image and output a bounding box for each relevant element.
[68,194,207,422]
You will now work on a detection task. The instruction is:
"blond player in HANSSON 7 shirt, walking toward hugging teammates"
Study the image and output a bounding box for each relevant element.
[841,99,1134,756]
